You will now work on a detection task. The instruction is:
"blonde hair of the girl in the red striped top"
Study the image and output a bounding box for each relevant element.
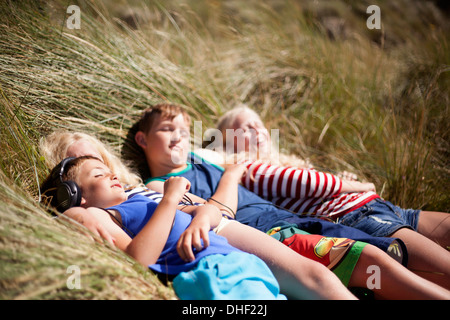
[217,104,313,169]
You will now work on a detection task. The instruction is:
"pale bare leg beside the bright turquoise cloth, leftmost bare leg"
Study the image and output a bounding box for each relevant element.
[219,221,355,299]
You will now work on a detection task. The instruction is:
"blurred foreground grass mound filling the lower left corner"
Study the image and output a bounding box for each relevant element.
[0,169,174,299]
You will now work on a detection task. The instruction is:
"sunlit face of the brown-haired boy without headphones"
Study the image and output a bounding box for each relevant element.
[141,114,190,171]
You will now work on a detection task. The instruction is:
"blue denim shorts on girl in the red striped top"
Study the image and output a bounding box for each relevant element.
[338,198,420,237]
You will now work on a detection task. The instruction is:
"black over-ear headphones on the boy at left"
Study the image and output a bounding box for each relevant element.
[47,157,81,212]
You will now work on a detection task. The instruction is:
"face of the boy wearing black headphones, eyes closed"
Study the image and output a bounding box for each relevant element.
[76,159,127,208]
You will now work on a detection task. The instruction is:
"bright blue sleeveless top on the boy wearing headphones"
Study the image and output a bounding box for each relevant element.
[108,195,240,275]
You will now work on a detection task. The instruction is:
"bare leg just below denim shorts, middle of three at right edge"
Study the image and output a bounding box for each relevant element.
[392,228,450,290]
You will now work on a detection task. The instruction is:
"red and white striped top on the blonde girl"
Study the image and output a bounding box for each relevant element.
[242,161,379,219]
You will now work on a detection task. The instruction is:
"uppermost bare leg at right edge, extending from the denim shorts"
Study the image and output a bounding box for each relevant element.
[417,211,450,250]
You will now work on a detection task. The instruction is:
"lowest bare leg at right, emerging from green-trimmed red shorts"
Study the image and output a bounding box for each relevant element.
[349,245,450,300]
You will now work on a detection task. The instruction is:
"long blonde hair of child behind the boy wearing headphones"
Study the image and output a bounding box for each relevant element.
[40,130,142,186]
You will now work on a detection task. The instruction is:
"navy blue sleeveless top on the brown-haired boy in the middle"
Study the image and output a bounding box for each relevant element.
[145,153,395,255]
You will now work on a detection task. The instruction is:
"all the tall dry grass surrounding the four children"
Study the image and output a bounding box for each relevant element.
[0,0,450,299]
